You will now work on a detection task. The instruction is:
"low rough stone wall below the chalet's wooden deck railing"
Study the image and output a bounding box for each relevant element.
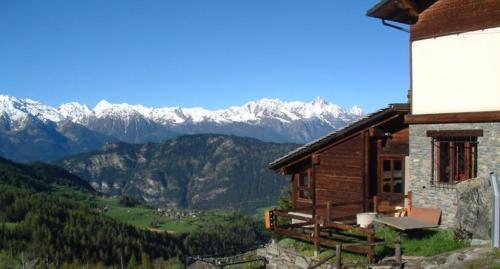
[257,243,335,269]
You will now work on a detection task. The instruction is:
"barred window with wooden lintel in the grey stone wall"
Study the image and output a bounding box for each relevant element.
[427,130,482,186]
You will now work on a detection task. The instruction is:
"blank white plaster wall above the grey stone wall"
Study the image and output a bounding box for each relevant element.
[411,27,500,114]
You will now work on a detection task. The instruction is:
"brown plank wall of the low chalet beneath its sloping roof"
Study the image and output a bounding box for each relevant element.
[288,114,409,217]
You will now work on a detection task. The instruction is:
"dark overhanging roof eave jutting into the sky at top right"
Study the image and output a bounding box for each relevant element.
[366,0,438,24]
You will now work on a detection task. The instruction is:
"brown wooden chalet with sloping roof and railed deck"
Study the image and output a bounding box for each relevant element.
[266,104,409,256]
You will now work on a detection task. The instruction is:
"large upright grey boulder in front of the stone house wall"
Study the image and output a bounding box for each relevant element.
[455,178,493,240]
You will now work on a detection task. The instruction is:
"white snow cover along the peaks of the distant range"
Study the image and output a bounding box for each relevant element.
[0,95,363,126]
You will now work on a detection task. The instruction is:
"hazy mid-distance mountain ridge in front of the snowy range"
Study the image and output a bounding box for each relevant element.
[59,134,298,209]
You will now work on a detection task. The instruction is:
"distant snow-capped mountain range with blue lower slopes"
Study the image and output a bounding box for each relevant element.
[0,95,363,160]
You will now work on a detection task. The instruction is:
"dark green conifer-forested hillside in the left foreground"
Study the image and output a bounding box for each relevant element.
[0,159,268,268]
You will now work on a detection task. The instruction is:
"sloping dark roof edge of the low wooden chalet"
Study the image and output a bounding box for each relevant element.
[269,103,410,170]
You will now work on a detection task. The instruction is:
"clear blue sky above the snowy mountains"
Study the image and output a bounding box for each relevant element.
[0,0,409,111]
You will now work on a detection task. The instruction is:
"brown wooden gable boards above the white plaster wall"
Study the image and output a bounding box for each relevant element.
[411,0,500,40]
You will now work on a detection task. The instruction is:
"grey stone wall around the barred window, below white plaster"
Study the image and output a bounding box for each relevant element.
[406,123,500,227]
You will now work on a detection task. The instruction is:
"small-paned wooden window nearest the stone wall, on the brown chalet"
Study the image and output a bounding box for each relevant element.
[379,157,404,194]
